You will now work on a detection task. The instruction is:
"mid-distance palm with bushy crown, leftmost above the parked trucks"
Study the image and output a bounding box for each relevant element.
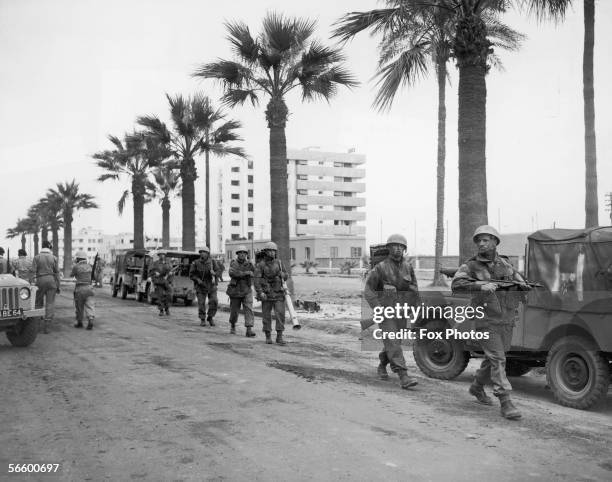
[92,132,168,249]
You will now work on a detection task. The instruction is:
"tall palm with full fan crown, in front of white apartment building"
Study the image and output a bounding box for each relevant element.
[194,13,357,288]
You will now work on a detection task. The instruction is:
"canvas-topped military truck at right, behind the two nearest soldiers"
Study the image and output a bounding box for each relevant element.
[413,227,612,409]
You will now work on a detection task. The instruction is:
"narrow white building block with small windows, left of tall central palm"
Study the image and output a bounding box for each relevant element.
[210,158,255,253]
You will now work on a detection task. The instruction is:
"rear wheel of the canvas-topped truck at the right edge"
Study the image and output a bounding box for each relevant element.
[546,336,610,410]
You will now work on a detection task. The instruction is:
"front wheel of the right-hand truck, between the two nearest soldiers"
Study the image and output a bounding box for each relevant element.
[412,320,470,380]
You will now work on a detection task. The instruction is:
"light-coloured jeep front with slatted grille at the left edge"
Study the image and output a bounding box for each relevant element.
[0,274,45,347]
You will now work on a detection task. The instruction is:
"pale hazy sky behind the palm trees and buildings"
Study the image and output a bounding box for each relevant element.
[0,0,612,254]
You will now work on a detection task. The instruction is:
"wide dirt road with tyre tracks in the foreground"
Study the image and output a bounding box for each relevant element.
[0,289,612,481]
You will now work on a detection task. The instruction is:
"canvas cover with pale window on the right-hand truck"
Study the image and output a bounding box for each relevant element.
[527,227,612,314]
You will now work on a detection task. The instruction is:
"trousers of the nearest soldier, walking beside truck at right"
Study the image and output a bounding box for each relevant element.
[475,325,513,395]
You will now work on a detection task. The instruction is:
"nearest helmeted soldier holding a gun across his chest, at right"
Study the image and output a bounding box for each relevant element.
[452,225,529,420]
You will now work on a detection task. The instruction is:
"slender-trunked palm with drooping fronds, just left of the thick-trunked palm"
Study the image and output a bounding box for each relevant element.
[334,0,523,286]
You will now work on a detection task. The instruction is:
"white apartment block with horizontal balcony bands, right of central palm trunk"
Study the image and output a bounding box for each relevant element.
[287,149,366,236]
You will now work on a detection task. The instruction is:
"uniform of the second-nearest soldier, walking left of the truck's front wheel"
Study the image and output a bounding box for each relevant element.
[364,257,419,373]
